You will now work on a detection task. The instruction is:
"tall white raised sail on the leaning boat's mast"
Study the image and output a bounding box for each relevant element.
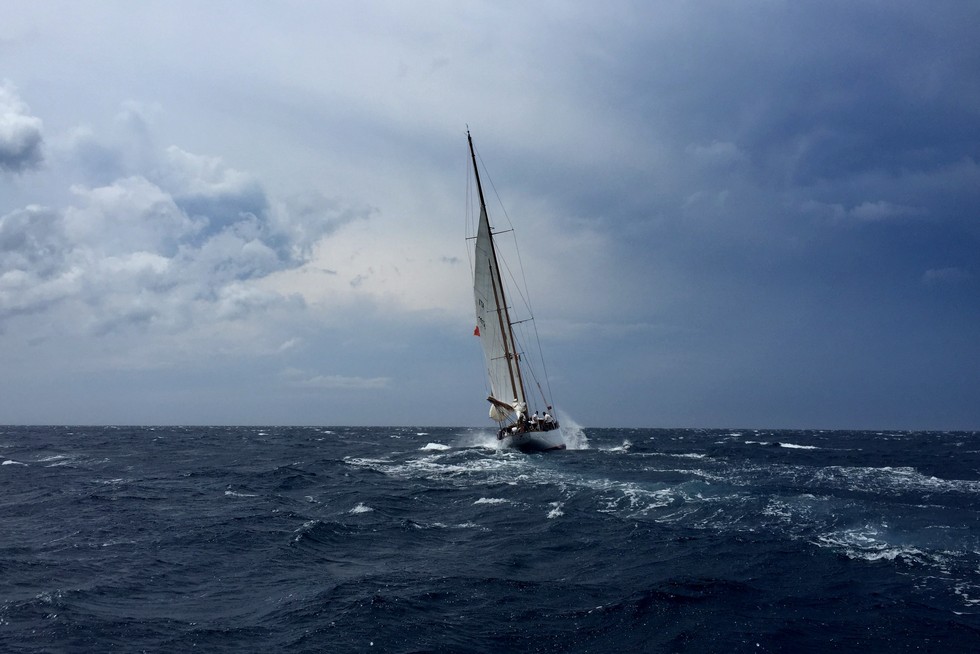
[473,208,524,422]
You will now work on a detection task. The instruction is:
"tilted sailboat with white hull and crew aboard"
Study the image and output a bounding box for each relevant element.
[466,130,565,452]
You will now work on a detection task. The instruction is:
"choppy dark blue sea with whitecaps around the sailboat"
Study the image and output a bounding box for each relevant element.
[0,426,980,653]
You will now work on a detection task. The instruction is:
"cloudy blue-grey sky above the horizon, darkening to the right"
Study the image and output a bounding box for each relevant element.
[0,0,980,430]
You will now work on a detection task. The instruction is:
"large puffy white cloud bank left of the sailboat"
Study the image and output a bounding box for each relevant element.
[0,111,371,346]
